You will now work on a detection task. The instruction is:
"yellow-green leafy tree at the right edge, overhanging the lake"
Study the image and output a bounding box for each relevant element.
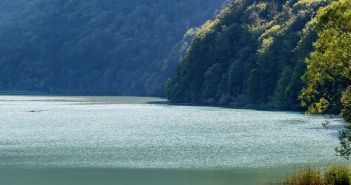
[301,0,351,117]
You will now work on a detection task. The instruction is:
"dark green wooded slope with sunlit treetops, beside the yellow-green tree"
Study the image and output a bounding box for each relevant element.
[167,0,332,110]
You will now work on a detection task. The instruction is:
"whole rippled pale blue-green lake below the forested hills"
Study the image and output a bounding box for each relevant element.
[0,96,345,185]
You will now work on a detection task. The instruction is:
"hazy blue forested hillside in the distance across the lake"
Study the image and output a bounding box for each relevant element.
[0,0,223,95]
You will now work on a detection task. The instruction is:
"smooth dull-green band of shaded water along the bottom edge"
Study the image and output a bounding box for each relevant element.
[0,168,308,185]
